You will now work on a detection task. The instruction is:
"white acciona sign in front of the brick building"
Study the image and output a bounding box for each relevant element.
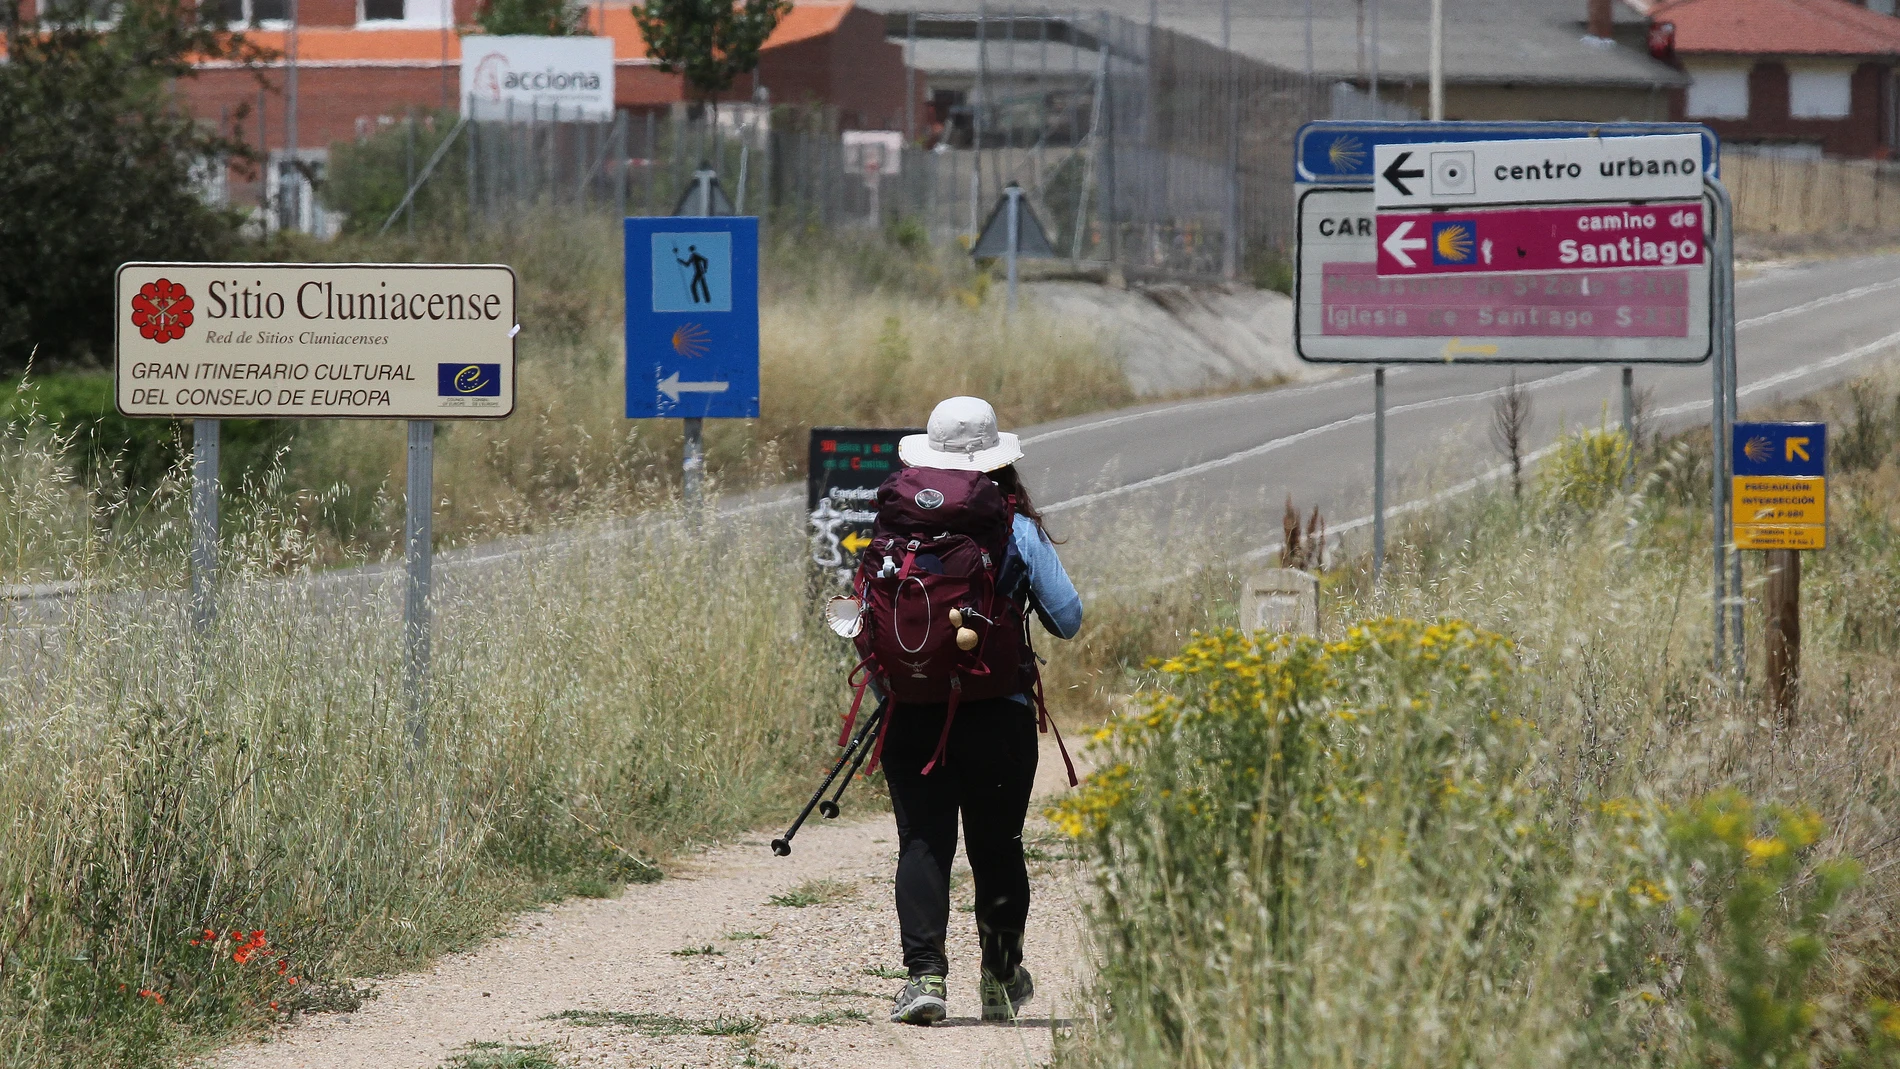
[462,34,614,122]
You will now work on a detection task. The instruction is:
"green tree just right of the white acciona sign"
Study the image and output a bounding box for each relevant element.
[633,0,792,108]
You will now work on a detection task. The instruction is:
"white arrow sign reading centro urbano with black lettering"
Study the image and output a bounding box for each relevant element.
[1372,133,1702,209]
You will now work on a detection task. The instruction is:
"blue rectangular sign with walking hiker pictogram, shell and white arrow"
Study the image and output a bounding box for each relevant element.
[625,216,758,420]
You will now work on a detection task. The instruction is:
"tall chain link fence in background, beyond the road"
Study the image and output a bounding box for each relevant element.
[319,13,1416,277]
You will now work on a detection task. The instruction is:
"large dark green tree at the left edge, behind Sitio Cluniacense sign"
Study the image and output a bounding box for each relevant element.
[0,0,266,374]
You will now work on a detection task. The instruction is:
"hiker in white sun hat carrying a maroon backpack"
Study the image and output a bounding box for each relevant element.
[859,397,1081,1025]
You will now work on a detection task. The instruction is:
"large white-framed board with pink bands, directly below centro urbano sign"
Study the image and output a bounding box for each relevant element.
[1294,188,1714,365]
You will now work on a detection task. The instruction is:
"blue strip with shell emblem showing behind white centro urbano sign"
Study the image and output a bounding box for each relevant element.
[1294,120,1721,186]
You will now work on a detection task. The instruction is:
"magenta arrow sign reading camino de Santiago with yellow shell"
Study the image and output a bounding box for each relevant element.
[1376,201,1704,275]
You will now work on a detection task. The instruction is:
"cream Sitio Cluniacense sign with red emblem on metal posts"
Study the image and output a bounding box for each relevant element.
[112,264,515,420]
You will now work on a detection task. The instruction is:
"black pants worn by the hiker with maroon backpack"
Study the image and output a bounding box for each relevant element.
[884,699,1036,978]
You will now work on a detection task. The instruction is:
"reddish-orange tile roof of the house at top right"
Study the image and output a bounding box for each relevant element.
[1649,0,1900,55]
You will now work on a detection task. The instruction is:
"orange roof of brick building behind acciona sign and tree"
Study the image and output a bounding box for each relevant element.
[215,0,851,66]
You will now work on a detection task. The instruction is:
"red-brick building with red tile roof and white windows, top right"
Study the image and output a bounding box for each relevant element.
[1649,0,1900,159]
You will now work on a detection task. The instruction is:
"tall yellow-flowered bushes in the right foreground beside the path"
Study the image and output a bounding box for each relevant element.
[1051,617,1900,1069]
